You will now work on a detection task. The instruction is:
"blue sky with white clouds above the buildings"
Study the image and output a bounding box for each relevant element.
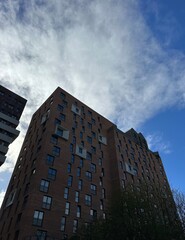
[0,0,185,205]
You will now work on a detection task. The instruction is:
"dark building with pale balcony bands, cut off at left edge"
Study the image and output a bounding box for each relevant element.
[0,85,26,165]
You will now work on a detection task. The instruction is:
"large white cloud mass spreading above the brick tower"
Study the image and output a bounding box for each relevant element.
[0,0,185,179]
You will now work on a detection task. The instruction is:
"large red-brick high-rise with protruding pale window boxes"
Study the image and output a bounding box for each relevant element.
[0,88,173,240]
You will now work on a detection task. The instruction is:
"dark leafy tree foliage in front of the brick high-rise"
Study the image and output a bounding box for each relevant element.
[74,185,185,240]
